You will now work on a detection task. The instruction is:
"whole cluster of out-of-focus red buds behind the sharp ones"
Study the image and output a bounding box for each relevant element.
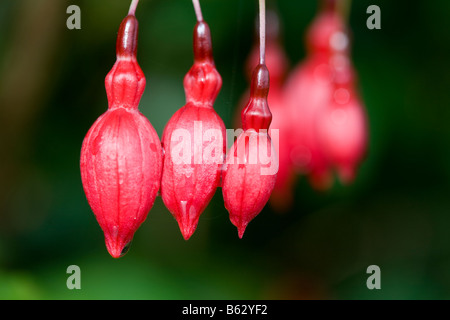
[237,0,368,210]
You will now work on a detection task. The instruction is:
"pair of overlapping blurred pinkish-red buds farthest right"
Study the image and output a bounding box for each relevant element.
[285,0,366,189]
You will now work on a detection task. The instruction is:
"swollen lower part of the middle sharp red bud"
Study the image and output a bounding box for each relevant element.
[161,103,225,240]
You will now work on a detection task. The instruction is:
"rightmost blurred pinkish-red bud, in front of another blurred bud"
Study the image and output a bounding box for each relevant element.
[318,54,367,184]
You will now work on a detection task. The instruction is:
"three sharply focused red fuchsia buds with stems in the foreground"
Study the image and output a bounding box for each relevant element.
[80,0,278,258]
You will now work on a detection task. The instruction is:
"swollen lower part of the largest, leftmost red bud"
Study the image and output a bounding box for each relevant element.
[81,108,161,258]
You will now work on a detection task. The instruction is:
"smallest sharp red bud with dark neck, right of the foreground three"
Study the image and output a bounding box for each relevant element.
[222,64,278,238]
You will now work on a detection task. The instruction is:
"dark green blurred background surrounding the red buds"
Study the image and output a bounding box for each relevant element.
[0,0,450,299]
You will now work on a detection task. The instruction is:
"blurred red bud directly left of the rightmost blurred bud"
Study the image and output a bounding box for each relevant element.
[284,0,348,190]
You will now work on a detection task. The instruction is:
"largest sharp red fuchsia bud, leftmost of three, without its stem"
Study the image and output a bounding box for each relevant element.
[80,14,162,258]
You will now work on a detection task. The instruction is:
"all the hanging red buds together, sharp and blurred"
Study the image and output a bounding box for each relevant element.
[80,0,367,258]
